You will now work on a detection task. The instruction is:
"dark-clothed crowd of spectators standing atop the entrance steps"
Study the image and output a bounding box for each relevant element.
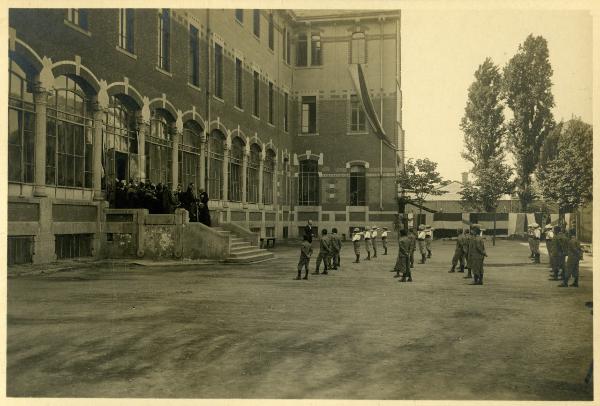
[107,179,211,226]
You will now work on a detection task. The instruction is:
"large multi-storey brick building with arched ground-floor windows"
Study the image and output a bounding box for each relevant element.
[8,9,404,263]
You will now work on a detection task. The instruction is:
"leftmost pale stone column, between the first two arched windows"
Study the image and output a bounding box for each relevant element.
[33,85,48,197]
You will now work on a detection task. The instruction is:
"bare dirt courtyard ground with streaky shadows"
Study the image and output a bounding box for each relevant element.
[7,241,593,400]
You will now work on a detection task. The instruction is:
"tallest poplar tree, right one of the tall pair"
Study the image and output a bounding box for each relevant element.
[502,34,554,211]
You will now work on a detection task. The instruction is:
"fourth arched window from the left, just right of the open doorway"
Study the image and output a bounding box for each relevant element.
[145,109,172,187]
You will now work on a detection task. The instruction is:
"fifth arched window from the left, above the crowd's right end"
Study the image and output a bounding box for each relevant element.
[179,120,203,190]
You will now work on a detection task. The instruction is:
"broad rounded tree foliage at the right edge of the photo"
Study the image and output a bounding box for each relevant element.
[538,119,593,213]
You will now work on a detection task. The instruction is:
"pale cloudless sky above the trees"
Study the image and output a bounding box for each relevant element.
[402,9,592,180]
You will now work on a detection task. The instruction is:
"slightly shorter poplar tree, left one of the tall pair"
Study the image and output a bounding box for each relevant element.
[460,58,513,244]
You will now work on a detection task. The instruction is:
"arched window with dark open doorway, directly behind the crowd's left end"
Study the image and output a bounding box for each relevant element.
[103,96,138,184]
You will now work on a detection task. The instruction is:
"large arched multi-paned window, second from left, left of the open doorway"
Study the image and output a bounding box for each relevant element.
[46,76,94,188]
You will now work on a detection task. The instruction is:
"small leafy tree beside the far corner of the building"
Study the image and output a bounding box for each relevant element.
[398,158,450,228]
